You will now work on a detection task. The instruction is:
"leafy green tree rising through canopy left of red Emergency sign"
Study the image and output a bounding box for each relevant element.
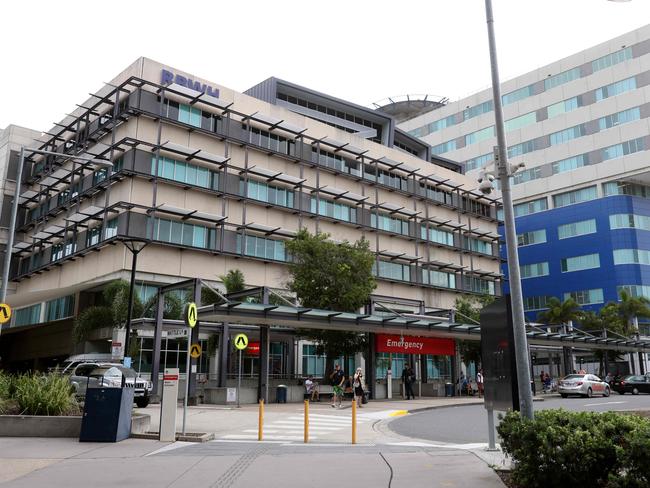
[285,229,377,371]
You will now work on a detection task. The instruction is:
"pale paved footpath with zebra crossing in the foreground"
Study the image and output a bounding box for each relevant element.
[0,397,504,488]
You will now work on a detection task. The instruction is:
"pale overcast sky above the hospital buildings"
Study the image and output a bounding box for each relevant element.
[0,0,650,130]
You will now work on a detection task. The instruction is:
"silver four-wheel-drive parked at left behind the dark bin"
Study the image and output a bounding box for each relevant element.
[70,363,153,408]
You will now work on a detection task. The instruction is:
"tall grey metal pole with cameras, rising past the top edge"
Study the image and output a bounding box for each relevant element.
[485,0,533,419]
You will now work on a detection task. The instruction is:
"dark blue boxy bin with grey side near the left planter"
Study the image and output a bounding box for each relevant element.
[79,386,134,442]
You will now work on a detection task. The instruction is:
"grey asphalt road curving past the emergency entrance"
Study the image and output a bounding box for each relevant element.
[388,392,650,444]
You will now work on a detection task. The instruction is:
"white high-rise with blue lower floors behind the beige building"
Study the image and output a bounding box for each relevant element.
[400,26,650,326]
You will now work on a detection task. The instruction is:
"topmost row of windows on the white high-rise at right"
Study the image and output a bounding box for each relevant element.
[409,47,632,137]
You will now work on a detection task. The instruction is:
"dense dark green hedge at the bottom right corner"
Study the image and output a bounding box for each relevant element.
[497,409,650,488]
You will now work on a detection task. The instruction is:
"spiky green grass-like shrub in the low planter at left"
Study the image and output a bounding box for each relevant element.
[13,374,79,415]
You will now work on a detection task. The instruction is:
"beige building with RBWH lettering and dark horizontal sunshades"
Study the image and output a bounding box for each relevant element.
[0,58,501,386]
